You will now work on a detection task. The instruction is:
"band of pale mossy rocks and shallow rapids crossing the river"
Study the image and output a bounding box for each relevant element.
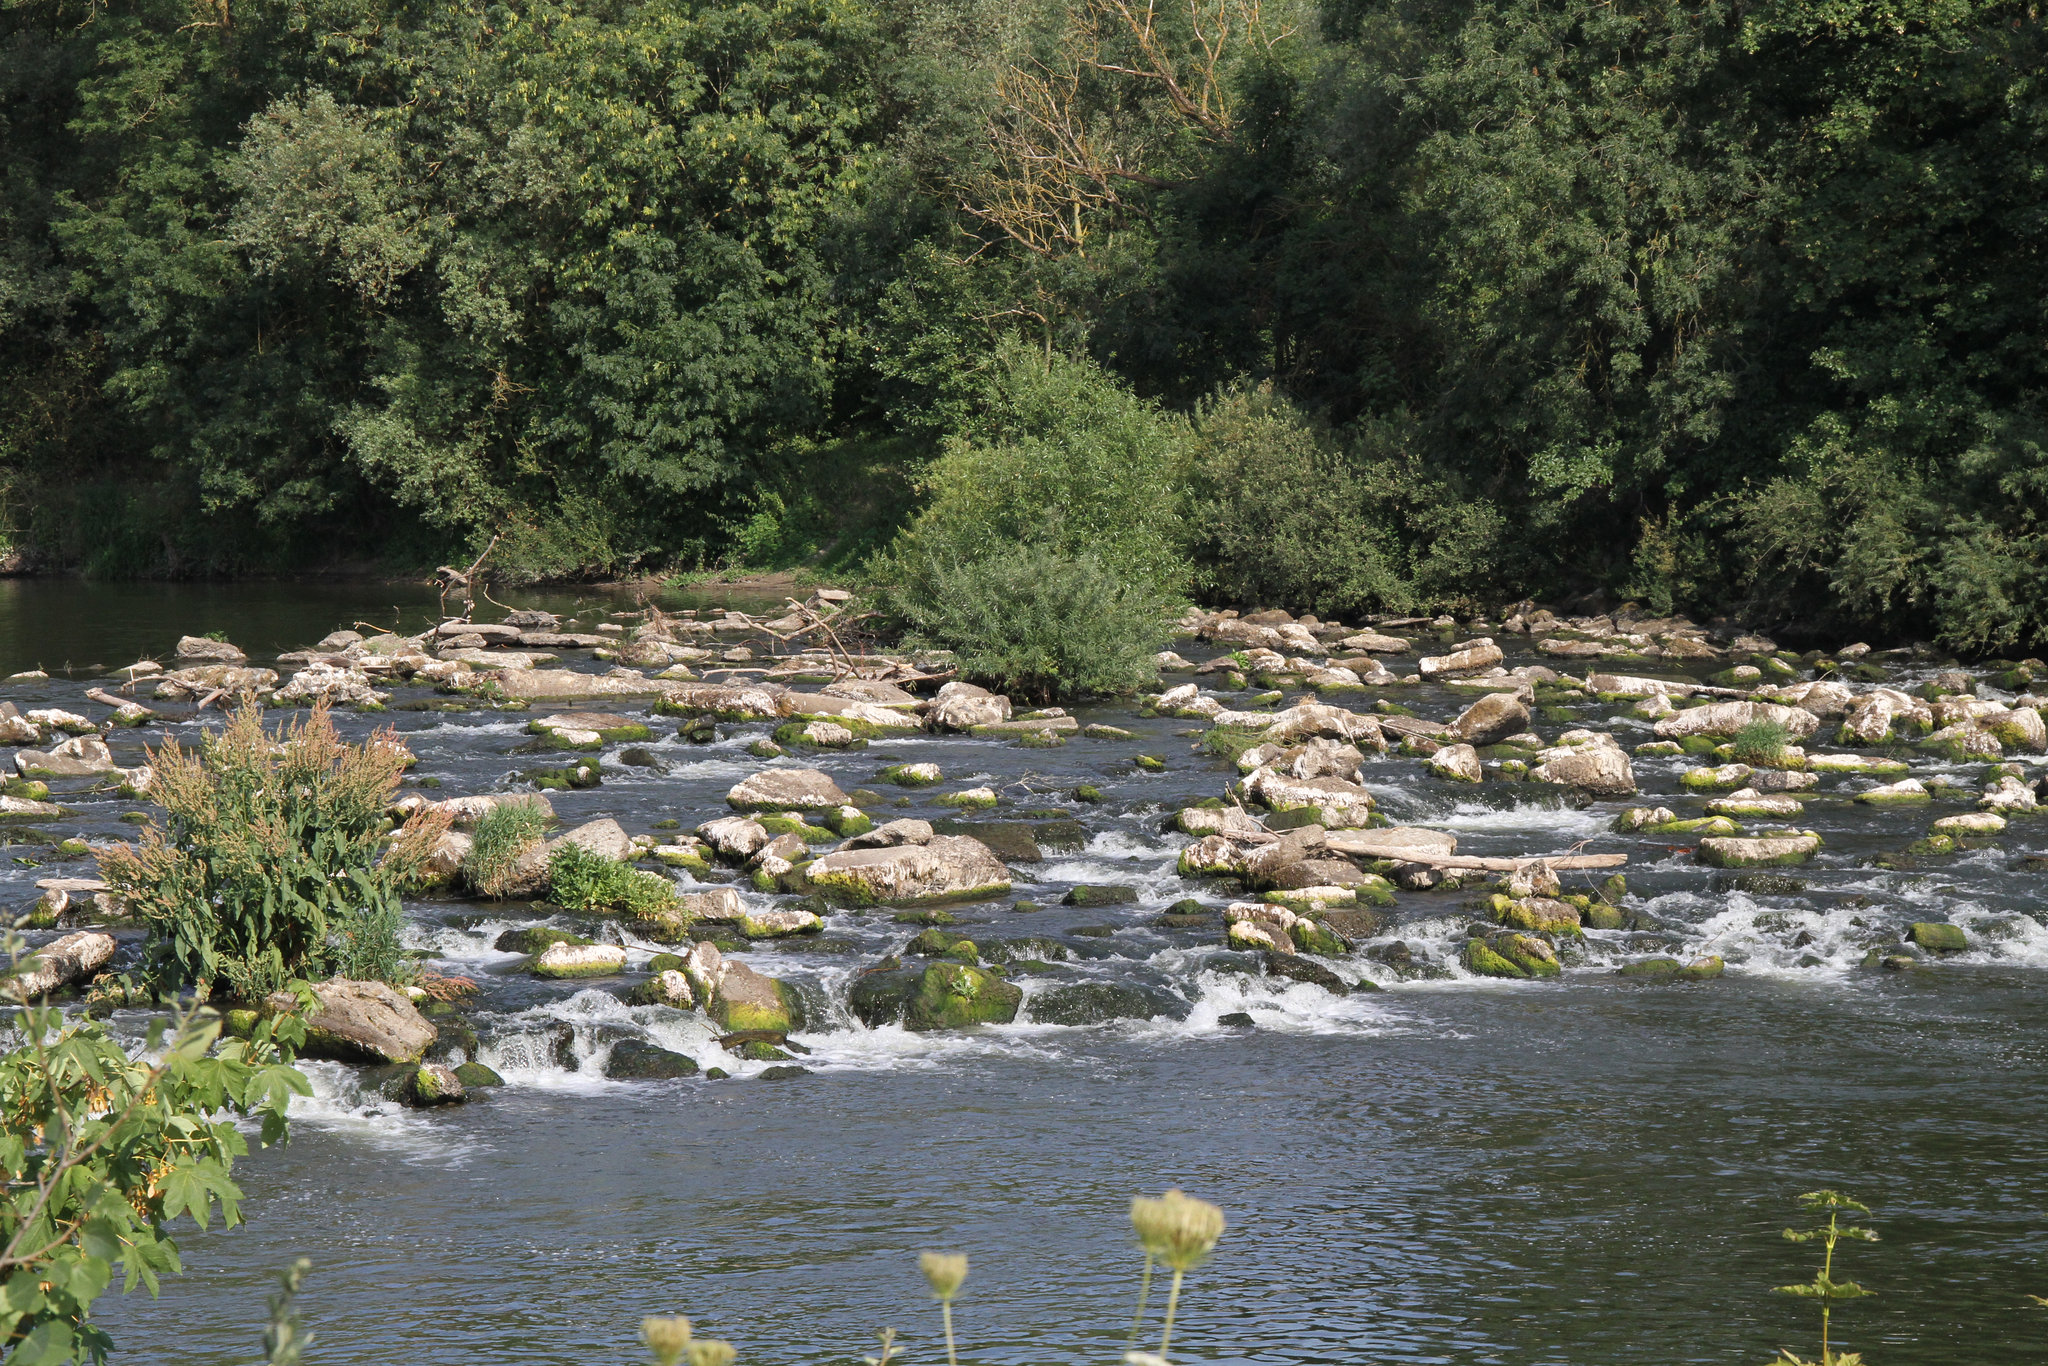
[0,594,2048,1108]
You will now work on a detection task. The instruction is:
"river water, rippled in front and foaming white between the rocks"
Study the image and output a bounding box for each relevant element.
[0,582,2048,1366]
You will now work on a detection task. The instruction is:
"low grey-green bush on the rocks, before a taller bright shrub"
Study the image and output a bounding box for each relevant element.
[889,545,1171,700]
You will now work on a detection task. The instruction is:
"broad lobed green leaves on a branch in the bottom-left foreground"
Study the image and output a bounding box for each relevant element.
[0,950,311,1366]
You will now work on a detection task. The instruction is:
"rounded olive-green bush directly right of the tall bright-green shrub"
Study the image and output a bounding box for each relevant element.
[1182,387,1409,616]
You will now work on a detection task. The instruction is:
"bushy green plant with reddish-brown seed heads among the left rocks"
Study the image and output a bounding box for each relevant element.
[100,702,432,999]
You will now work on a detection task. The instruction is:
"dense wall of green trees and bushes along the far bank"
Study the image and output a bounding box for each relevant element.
[0,0,2048,651]
